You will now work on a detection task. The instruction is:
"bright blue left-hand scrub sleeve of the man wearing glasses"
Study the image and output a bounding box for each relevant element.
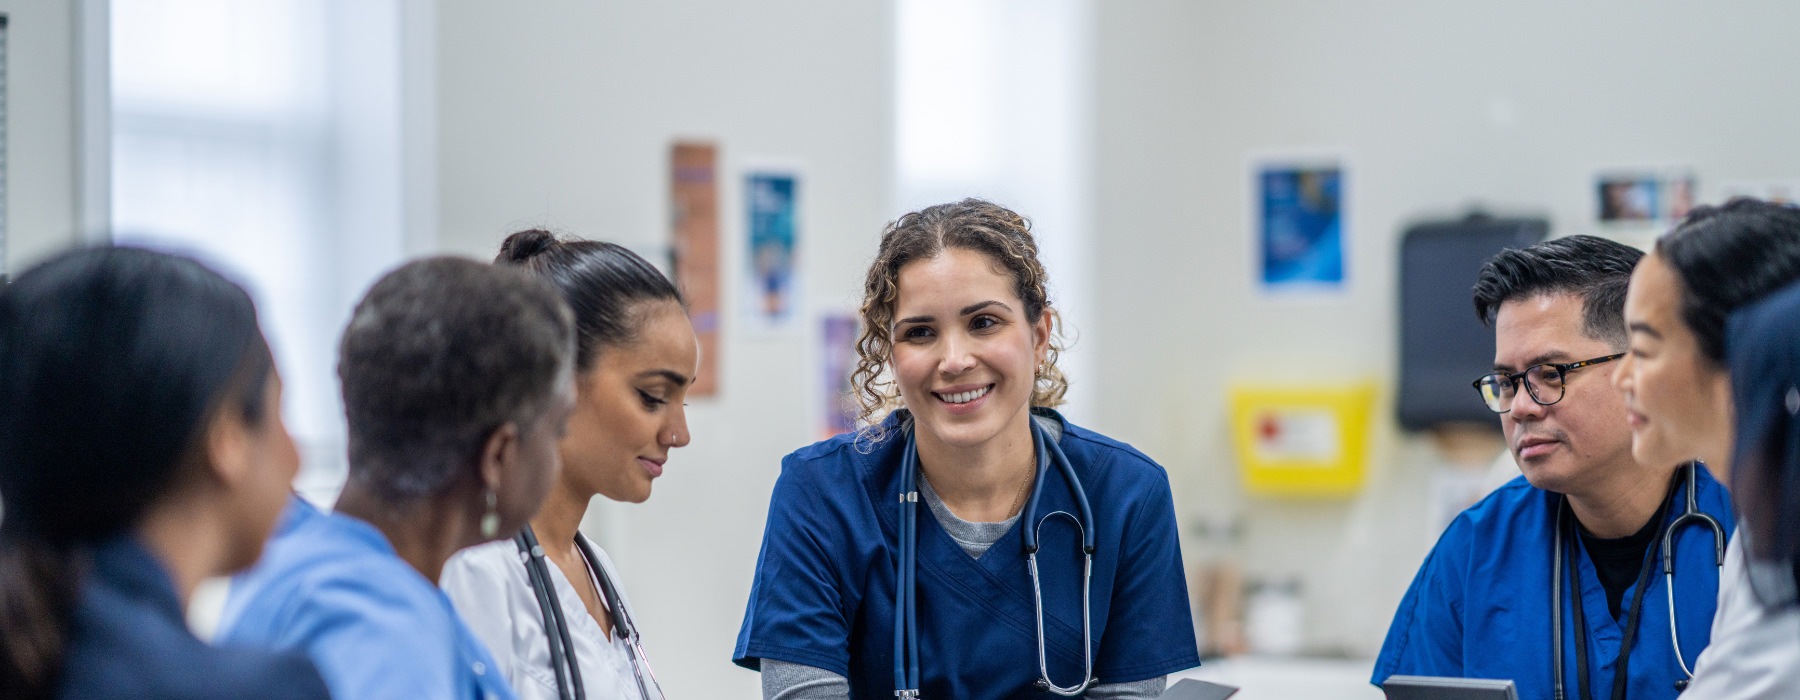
[1370,518,1471,687]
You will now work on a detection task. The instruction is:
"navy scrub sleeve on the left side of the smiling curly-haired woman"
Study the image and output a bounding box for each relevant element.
[733,455,864,677]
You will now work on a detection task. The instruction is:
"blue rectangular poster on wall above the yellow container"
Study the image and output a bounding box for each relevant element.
[1256,164,1345,292]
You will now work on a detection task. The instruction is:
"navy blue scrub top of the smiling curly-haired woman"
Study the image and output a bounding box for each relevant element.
[733,410,1201,700]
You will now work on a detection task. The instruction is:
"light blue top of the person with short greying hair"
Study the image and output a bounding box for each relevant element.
[220,497,515,700]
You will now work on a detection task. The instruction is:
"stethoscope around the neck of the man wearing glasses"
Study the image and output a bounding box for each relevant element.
[1550,462,1724,700]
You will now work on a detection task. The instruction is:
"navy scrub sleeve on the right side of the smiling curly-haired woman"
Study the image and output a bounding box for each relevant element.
[1094,470,1201,684]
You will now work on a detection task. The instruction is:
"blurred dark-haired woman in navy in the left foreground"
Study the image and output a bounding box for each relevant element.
[0,248,328,700]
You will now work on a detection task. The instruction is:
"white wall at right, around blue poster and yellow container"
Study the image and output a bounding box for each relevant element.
[1087,0,1800,653]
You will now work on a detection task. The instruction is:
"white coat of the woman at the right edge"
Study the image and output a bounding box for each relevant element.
[1676,527,1800,700]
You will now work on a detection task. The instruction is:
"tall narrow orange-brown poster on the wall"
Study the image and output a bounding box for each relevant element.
[670,142,720,396]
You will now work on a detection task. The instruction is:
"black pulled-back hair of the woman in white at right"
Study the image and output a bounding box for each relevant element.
[1654,198,1800,365]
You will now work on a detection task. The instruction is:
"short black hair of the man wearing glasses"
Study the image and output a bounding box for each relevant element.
[1474,236,1643,347]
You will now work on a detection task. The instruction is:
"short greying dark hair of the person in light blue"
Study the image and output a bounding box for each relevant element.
[338,257,574,502]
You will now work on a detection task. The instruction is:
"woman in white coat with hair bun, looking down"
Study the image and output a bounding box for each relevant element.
[443,230,698,700]
